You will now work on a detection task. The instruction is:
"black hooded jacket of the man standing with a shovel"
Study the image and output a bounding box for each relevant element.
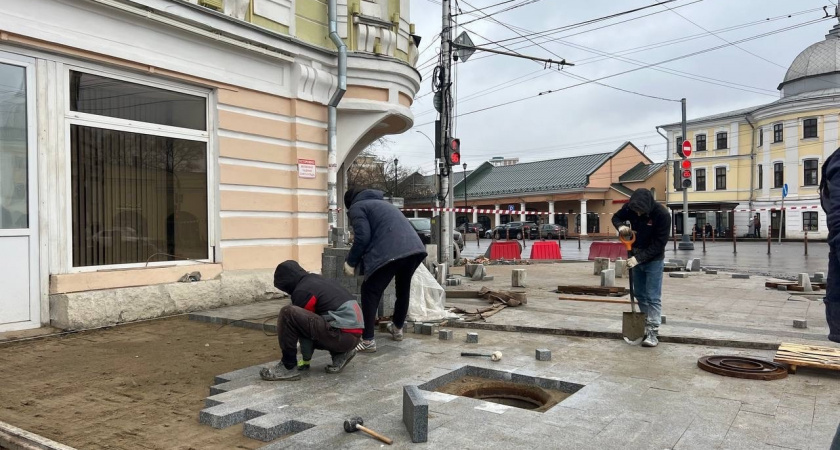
[612,189,671,264]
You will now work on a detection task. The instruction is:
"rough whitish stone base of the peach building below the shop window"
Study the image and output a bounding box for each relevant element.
[50,270,284,330]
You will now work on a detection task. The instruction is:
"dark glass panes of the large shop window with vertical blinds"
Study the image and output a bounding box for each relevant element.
[70,72,208,267]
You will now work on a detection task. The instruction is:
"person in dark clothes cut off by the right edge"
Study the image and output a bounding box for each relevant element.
[820,149,840,342]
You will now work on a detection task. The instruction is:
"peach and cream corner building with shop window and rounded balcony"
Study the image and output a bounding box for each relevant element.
[0,0,420,331]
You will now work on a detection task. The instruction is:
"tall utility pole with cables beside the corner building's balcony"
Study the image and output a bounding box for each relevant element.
[437,0,453,281]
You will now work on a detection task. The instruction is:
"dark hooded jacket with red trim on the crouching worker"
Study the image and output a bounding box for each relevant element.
[274,261,365,335]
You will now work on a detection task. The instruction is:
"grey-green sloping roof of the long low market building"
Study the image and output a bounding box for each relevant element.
[455,152,612,197]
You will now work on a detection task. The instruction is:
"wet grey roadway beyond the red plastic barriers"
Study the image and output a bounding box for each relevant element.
[462,239,828,277]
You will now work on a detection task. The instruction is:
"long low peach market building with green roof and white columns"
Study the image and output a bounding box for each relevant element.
[404,142,665,236]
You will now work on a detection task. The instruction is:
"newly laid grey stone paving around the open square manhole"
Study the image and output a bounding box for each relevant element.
[190,303,840,450]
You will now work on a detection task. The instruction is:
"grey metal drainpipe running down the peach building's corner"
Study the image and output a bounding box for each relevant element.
[327,0,347,244]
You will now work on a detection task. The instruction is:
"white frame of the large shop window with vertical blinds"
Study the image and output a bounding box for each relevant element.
[65,64,219,273]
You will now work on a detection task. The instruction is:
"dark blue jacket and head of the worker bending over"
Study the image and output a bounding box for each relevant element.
[345,189,426,278]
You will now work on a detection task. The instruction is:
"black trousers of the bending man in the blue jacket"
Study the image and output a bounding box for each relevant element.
[362,255,426,341]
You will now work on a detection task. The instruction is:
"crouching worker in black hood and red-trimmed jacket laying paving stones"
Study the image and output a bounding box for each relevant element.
[260,261,364,381]
